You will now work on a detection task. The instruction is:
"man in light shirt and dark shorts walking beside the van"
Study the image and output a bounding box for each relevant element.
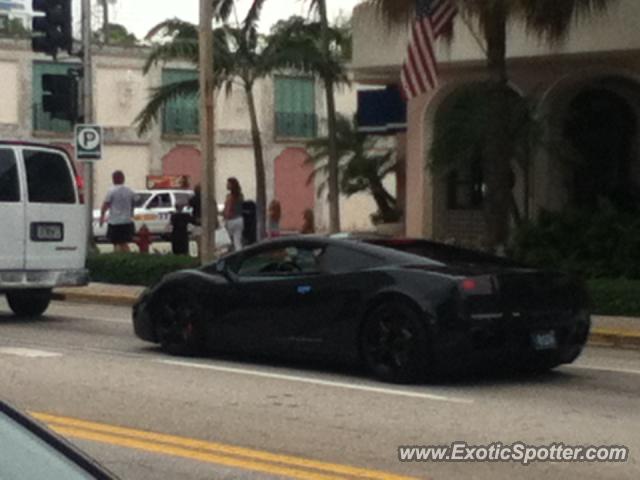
[100,170,135,252]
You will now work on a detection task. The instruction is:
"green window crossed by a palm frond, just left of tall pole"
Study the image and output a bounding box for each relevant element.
[162,69,199,135]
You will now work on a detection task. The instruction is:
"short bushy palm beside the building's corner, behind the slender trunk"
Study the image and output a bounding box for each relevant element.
[307,115,400,223]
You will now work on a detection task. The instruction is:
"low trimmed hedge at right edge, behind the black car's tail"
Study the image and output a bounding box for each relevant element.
[587,278,640,317]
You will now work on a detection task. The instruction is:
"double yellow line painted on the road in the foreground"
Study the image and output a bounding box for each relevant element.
[31,412,415,480]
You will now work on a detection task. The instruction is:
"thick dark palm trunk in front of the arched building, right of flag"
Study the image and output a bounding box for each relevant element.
[483,0,513,251]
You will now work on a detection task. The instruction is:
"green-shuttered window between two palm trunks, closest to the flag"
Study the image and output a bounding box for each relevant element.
[274,76,317,138]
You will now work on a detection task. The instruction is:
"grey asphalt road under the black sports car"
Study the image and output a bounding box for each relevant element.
[0,299,640,480]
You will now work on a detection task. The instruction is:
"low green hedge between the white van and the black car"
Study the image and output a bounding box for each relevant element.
[87,253,200,285]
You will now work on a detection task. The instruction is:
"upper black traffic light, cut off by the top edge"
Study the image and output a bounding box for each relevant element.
[31,0,73,58]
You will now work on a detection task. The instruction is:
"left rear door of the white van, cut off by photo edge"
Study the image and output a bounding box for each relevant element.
[0,148,25,270]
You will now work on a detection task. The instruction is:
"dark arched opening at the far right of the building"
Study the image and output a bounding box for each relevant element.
[563,85,640,210]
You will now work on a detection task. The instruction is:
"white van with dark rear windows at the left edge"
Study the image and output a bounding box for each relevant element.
[0,141,89,316]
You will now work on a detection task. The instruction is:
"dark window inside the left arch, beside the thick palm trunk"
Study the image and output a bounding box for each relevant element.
[447,161,485,210]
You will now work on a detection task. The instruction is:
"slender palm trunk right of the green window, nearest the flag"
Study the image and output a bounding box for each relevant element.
[318,0,340,233]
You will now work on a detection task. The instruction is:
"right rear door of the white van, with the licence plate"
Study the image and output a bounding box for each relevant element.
[22,147,87,270]
